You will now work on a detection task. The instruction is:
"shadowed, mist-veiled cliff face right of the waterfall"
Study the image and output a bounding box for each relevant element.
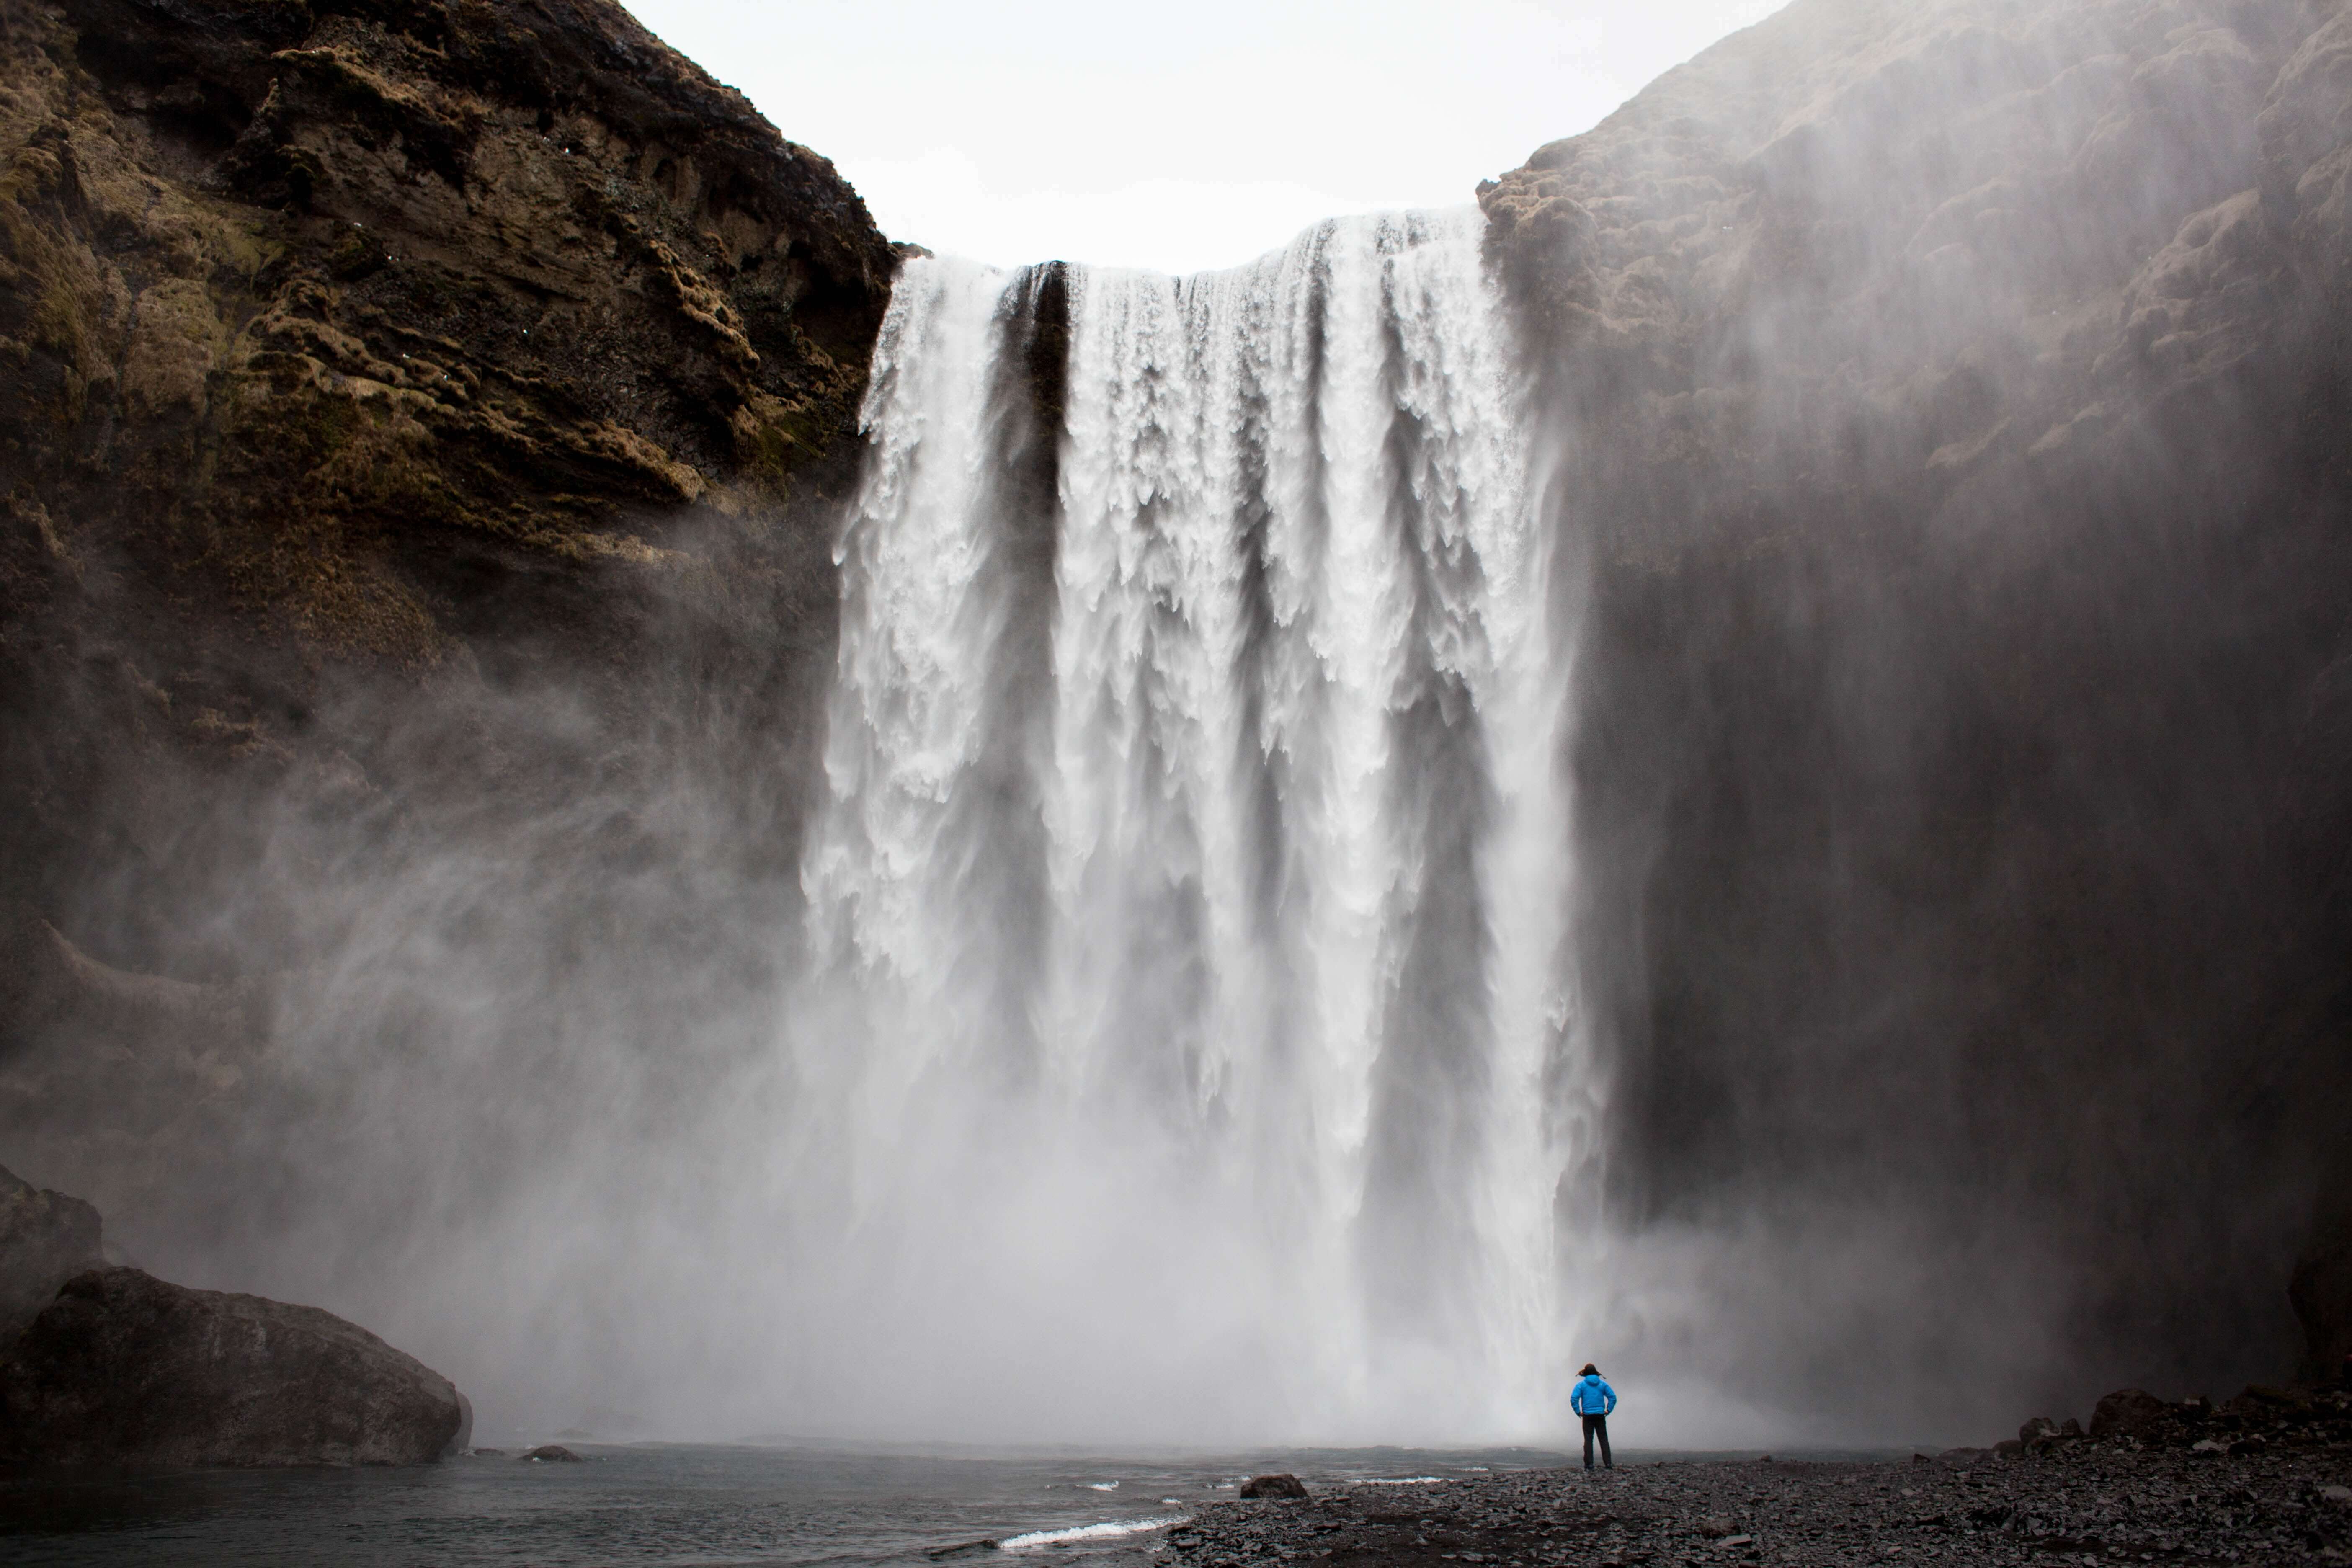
[1479,0,2352,1413]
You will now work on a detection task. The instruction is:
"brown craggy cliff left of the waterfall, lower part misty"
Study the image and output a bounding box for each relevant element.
[0,0,896,1302]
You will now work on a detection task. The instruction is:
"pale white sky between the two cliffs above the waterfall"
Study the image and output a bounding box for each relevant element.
[630,0,1780,273]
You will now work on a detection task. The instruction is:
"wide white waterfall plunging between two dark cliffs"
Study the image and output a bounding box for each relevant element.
[788,211,1576,1439]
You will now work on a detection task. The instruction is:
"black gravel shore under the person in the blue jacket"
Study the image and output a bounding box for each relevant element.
[1153,1444,2352,1568]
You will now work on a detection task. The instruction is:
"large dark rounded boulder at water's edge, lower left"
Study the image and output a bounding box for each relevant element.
[0,1269,473,1467]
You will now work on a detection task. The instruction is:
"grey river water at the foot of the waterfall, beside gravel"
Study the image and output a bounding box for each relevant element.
[0,1444,1562,1568]
